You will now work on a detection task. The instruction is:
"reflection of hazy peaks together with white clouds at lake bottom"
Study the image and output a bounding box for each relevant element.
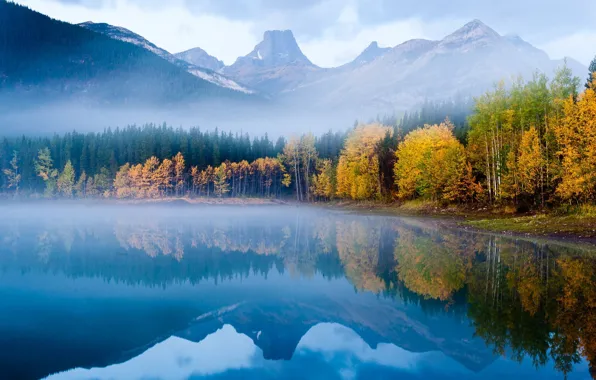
[44,297,495,379]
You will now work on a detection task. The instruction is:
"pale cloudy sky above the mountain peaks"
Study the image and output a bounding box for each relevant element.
[46,0,596,38]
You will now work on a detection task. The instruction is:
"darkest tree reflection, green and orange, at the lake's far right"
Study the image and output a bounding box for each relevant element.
[468,237,596,373]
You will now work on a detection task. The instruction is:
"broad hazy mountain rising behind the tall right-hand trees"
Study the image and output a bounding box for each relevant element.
[286,20,587,112]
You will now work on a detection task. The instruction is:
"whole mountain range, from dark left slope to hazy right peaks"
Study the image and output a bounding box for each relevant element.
[0,0,587,115]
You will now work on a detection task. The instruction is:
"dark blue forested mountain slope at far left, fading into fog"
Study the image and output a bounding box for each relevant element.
[0,1,250,105]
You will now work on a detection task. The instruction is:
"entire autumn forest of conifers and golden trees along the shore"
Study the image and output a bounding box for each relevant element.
[0,63,596,209]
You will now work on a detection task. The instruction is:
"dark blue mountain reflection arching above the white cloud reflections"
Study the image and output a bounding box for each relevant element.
[0,268,495,378]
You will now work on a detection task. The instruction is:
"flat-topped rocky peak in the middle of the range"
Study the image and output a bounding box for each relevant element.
[223,30,322,93]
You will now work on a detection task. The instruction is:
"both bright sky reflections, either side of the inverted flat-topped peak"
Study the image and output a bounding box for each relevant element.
[47,323,469,380]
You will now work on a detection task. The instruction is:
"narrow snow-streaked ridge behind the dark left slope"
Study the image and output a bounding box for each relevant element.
[79,21,254,94]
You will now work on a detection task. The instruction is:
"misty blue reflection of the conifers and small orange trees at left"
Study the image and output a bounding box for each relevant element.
[0,214,350,285]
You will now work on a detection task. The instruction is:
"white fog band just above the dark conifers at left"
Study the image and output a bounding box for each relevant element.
[0,98,377,138]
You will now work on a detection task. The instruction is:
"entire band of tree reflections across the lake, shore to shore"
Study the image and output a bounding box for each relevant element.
[0,213,596,373]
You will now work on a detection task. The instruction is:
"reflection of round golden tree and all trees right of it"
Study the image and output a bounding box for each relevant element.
[384,220,596,373]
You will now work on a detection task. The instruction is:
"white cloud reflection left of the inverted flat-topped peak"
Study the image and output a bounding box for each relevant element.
[47,325,262,380]
